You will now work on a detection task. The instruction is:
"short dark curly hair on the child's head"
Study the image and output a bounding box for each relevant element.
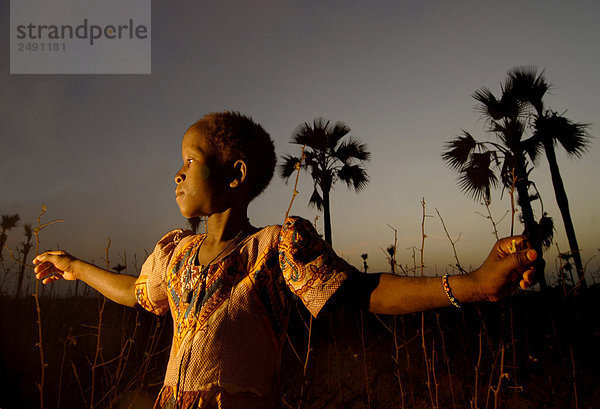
[192,111,277,200]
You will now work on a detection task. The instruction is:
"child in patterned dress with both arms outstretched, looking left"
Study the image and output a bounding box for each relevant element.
[33,112,536,409]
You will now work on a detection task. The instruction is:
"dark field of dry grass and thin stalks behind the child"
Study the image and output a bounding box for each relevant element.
[0,202,600,409]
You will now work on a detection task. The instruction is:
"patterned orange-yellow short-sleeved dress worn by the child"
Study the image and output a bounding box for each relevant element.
[135,217,356,409]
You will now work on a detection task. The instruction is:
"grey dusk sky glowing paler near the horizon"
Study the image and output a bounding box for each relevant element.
[0,0,600,282]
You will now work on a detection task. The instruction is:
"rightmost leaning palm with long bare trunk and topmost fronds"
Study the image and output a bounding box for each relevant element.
[508,67,590,285]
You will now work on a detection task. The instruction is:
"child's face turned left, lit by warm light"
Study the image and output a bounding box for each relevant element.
[175,126,227,218]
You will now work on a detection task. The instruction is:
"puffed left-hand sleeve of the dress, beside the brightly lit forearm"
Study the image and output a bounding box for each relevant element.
[135,229,192,315]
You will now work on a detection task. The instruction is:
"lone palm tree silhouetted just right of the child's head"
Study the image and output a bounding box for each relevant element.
[279,118,371,244]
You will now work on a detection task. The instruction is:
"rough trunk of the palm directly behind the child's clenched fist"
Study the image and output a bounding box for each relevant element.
[515,161,548,290]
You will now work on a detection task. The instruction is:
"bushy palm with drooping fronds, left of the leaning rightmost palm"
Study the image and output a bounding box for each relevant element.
[442,80,553,288]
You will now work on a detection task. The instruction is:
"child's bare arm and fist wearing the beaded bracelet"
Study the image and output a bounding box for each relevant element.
[369,236,537,314]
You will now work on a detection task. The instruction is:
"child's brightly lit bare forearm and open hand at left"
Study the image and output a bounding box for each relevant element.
[33,251,137,307]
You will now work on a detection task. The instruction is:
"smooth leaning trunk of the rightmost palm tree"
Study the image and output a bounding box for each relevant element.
[544,141,585,286]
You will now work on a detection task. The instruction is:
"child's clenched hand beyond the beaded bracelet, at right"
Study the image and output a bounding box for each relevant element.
[471,236,537,301]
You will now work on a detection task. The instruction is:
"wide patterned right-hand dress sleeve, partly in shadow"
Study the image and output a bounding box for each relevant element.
[279,217,357,317]
